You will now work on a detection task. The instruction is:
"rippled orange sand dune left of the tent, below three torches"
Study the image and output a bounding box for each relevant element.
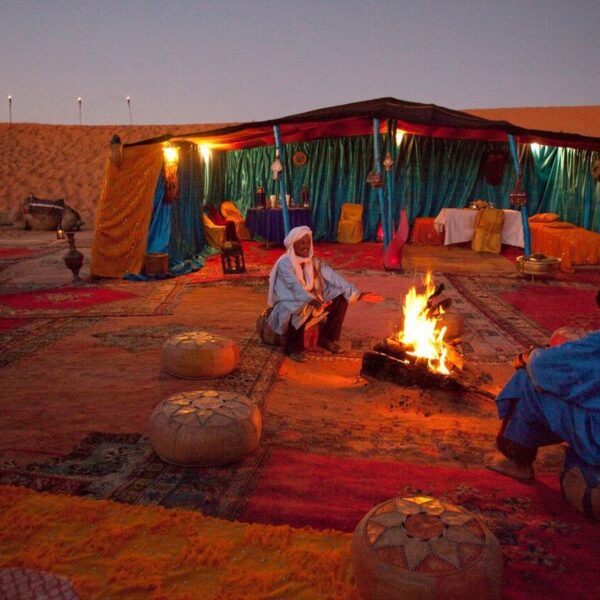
[0,123,230,229]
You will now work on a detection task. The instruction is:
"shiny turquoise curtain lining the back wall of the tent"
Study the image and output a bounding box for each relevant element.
[215,135,600,240]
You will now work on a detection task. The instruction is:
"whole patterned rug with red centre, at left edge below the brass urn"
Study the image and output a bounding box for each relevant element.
[0,279,186,319]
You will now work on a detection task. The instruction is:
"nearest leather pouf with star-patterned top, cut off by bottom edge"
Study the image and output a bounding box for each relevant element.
[352,496,502,600]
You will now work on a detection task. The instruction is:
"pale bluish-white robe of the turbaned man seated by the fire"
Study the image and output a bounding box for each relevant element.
[268,256,360,335]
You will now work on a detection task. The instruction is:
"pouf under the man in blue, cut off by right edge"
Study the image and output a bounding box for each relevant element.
[560,448,600,521]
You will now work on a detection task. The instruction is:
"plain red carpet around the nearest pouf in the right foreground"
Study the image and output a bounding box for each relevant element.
[241,449,600,600]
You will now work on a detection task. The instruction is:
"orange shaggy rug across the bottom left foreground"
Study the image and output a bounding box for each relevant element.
[0,486,358,600]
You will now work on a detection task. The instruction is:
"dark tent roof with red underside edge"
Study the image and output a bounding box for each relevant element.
[128,98,600,151]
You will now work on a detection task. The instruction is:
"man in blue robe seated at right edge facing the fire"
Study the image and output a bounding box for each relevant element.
[488,292,600,480]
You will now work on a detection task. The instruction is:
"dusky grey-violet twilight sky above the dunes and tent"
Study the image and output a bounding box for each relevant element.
[0,0,600,125]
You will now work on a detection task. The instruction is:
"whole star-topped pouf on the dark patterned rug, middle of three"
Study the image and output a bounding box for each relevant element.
[148,390,262,467]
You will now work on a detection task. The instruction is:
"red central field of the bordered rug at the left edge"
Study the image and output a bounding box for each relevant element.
[0,287,136,310]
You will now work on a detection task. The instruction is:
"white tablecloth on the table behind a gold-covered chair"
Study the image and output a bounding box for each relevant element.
[433,208,525,248]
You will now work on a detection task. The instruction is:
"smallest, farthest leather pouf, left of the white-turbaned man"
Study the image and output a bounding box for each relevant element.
[162,331,240,379]
